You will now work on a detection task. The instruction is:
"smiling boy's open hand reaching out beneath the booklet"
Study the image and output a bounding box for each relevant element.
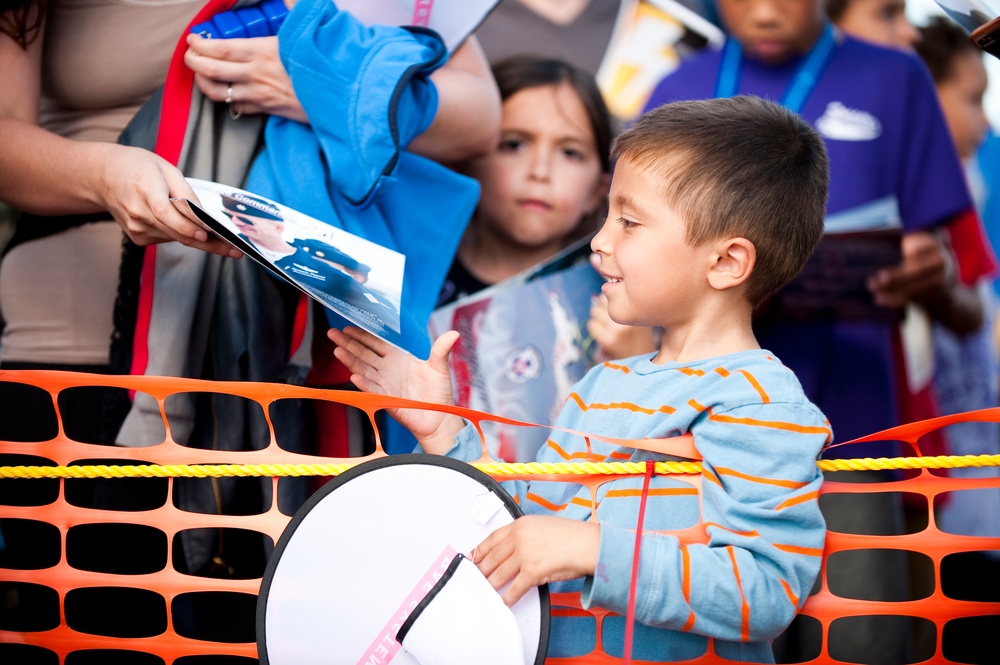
[327,326,465,455]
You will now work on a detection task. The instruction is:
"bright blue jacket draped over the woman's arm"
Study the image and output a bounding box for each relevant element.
[247,0,479,358]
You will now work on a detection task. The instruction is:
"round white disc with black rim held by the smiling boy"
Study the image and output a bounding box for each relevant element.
[257,454,549,665]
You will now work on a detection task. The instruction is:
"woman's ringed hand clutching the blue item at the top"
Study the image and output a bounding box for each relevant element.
[184,34,309,123]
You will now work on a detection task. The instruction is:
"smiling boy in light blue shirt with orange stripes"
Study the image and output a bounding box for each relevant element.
[330,97,832,662]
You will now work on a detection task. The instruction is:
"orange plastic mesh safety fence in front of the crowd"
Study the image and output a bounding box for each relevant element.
[0,371,1000,665]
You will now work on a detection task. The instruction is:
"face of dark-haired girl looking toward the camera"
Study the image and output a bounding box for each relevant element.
[468,83,606,251]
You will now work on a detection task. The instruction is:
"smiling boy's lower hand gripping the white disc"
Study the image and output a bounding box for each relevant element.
[472,515,601,607]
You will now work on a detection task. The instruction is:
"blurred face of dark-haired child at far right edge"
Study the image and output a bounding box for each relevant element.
[937,51,989,159]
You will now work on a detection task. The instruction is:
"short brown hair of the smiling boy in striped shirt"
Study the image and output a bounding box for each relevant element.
[611,95,830,308]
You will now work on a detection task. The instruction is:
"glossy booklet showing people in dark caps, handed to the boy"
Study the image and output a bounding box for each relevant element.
[177,178,406,349]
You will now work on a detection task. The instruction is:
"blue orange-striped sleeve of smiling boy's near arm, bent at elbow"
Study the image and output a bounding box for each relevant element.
[581,396,830,642]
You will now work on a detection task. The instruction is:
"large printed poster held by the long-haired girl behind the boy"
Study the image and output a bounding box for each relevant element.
[430,237,603,462]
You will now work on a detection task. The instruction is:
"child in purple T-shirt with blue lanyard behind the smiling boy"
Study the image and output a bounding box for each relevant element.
[647,0,995,665]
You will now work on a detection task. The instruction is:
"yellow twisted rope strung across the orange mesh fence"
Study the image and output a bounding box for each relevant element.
[0,455,1000,478]
